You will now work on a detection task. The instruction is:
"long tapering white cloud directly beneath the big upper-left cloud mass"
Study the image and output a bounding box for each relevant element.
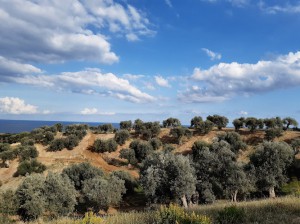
[11,69,155,103]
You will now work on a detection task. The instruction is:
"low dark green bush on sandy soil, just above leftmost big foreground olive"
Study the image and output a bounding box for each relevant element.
[14,159,46,177]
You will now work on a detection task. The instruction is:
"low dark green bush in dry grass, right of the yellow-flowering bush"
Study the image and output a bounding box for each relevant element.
[217,206,246,224]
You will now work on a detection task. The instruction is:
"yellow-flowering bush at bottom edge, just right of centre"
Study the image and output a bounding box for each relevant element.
[156,204,212,224]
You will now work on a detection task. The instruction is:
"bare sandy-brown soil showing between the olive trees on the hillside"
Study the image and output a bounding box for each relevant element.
[0,128,300,189]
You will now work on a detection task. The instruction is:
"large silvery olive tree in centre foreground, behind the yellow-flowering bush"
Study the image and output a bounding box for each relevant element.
[140,152,196,207]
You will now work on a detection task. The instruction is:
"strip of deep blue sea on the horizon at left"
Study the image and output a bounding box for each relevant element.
[0,119,120,134]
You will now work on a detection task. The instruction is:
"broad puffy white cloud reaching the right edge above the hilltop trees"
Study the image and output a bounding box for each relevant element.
[179,52,300,102]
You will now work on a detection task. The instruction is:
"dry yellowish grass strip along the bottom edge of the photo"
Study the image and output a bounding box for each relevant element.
[12,197,300,224]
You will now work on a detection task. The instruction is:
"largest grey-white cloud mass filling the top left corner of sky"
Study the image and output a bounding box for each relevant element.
[0,0,154,64]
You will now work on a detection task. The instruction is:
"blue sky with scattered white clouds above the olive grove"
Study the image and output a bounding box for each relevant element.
[0,0,300,124]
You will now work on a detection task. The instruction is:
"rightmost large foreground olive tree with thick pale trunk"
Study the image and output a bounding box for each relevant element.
[250,142,294,198]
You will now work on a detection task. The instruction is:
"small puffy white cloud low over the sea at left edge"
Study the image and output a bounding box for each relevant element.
[0,97,38,114]
